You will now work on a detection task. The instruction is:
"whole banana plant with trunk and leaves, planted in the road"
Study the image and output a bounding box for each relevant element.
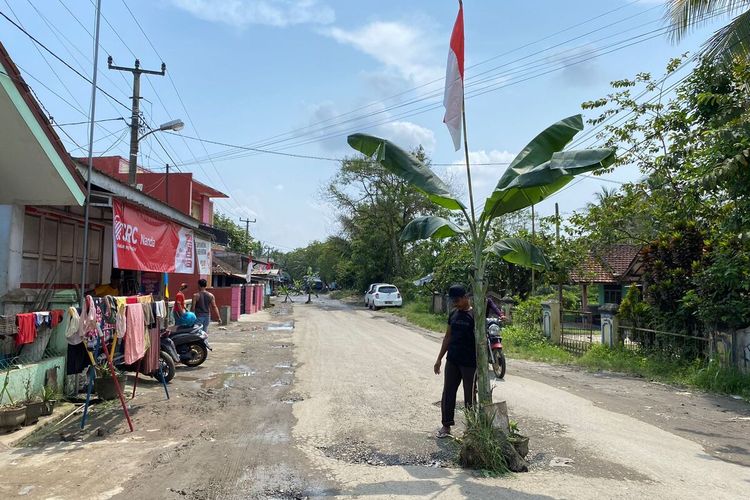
[348,115,615,404]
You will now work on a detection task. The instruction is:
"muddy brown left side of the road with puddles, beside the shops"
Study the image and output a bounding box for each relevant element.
[0,304,333,500]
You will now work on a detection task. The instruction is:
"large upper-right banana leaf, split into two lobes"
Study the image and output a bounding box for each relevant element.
[482,115,615,220]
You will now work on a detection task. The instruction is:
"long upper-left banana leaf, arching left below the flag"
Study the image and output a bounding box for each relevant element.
[347,134,466,210]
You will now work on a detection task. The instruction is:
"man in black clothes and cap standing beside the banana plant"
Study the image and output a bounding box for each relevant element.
[434,285,477,438]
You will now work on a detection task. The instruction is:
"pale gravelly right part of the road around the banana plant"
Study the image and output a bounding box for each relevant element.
[294,300,750,498]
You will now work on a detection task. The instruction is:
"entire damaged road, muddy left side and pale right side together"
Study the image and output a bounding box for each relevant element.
[0,297,750,500]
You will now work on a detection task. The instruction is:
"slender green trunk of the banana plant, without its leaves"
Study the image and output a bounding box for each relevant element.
[471,245,492,406]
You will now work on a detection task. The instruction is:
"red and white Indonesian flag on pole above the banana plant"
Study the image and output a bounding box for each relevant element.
[443,0,464,151]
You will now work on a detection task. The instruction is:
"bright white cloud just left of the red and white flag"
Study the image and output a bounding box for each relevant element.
[324,21,447,85]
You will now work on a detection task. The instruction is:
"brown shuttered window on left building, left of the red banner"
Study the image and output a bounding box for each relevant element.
[21,211,104,284]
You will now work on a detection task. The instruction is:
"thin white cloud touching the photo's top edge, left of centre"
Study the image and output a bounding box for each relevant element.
[171,0,336,27]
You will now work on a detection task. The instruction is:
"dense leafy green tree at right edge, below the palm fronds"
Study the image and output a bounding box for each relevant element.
[570,60,750,333]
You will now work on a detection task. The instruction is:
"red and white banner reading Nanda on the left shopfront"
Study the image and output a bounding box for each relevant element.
[112,200,195,274]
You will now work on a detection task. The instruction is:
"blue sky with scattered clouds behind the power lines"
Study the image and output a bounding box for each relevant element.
[0,0,726,250]
